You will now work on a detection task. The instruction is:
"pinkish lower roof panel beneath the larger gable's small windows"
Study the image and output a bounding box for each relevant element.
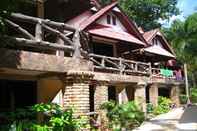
[88,26,145,46]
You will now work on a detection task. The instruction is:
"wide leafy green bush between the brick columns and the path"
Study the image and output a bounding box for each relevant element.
[101,101,145,131]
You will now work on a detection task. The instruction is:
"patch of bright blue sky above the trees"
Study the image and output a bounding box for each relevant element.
[162,0,197,27]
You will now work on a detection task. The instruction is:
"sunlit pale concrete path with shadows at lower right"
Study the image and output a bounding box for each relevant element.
[134,106,197,131]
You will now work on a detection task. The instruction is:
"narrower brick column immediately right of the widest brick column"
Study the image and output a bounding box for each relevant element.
[94,83,108,111]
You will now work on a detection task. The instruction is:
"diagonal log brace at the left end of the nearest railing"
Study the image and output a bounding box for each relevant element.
[5,19,35,40]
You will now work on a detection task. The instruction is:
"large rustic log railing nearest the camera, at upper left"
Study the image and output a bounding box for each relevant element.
[1,13,85,57]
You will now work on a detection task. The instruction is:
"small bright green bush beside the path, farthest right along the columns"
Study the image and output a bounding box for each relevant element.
[153,96,172,115]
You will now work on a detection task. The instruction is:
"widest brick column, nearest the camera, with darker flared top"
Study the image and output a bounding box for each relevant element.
[64,72,92,114]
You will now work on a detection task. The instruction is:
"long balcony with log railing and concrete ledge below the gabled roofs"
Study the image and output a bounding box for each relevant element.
[89,54,184,84]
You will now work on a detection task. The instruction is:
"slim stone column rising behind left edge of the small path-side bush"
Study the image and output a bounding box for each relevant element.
[149,84,159,107]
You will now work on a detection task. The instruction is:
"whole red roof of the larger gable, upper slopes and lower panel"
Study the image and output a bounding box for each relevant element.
[67,2,146,45]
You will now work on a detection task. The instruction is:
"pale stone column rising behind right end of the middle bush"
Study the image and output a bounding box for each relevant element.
[135,82,146,113]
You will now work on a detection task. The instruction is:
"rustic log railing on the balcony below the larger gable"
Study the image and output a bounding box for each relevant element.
[89,54,151,75]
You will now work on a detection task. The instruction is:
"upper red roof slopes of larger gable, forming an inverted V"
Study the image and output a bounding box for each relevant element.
[67,2,147,44]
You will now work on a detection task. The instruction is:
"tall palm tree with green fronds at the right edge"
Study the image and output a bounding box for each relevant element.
[164,13,197,102]
